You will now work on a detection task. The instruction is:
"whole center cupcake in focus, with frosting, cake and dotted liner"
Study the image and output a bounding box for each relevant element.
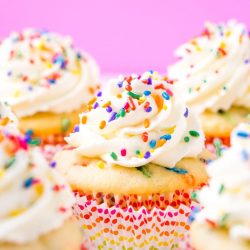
[55,71,207,249]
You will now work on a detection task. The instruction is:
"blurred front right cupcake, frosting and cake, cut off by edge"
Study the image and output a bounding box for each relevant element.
[191,123,250,250]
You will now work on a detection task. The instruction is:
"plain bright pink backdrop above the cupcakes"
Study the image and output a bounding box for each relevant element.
[0,0,250,73]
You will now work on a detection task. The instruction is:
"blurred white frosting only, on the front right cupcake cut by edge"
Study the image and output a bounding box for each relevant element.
[197,123,250,240]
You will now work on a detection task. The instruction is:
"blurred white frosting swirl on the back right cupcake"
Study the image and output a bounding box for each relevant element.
[168,20,250,112]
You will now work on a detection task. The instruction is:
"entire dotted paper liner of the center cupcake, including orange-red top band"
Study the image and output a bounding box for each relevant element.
[73,191,201,250]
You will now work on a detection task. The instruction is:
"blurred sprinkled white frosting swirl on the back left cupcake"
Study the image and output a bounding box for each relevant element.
[0,29,98,117]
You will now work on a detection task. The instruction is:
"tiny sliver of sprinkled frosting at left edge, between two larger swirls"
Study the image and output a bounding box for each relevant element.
[0,102,18,127]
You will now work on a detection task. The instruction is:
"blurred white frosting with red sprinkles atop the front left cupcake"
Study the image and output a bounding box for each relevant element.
[0,126,74,244]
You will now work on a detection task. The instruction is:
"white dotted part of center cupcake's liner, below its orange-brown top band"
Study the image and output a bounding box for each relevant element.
[73,195,199,250]
